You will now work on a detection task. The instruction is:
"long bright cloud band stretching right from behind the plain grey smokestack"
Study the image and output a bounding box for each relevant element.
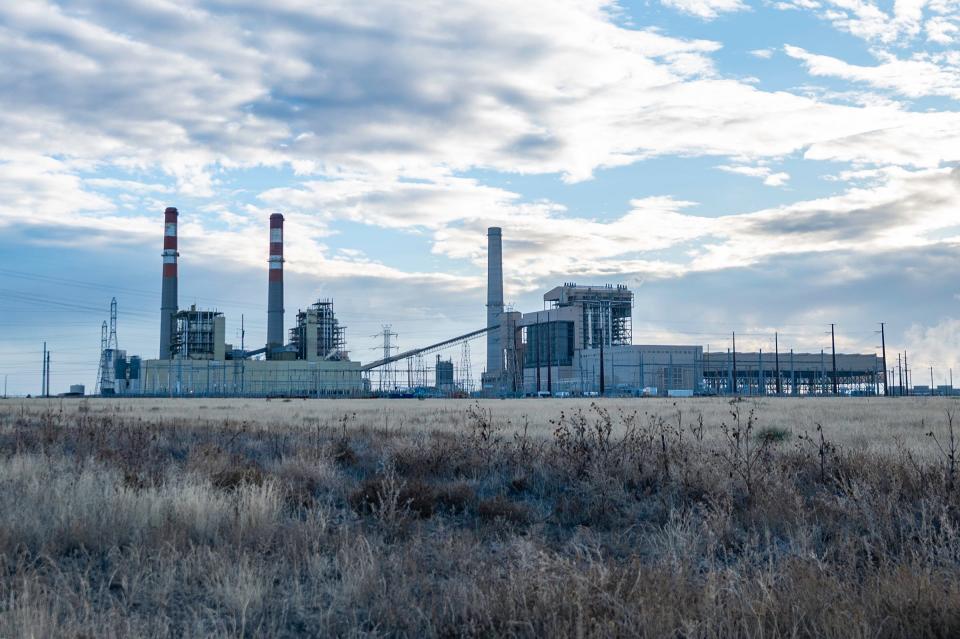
[410,167,960,287]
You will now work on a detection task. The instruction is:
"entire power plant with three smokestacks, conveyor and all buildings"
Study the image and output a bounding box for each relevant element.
[97,207,886,397]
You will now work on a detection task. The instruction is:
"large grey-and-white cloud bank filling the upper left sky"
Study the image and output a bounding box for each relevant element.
[0,0,955,197]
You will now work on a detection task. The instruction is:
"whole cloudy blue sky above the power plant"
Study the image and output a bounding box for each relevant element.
[0,0,960,394]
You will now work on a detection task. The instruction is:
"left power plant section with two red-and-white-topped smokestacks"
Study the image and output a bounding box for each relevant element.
[101,208,365,397]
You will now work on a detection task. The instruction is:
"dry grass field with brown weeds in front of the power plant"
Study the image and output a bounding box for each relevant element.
[0,398,960,638]
